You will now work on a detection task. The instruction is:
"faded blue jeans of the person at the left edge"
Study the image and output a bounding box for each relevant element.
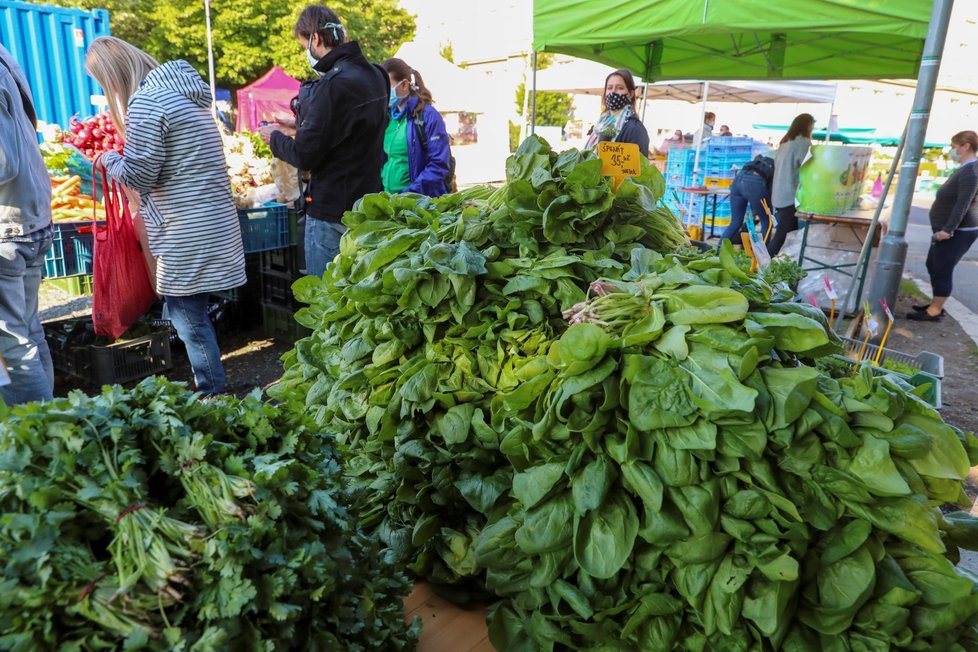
[0,226,54,405]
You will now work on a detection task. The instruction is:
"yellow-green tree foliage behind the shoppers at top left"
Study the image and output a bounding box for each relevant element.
[28,0,415,88]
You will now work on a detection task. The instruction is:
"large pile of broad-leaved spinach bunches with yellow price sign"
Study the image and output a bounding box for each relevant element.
[271,138,978,651]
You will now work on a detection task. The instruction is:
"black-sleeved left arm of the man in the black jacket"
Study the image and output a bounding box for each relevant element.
[268,79,355,170]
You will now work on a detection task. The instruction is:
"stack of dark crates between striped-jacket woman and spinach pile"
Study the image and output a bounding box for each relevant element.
[259,211,309,343]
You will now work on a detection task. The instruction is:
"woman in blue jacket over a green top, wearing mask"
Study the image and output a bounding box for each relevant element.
[380,59,452,197]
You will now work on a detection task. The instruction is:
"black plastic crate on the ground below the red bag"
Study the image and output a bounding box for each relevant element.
[46,317,173,385]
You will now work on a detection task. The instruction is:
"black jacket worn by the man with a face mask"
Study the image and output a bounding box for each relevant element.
[270,41,390,222]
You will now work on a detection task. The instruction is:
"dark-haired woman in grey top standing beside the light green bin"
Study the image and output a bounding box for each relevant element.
[767,113,815,256]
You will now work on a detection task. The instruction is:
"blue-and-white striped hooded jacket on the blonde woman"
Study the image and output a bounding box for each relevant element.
[103,61,247,296]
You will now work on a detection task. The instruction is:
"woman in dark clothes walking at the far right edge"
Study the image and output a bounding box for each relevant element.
[907,131,978,321]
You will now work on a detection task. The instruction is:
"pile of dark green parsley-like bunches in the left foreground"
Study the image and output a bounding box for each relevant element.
[0,378,420,652]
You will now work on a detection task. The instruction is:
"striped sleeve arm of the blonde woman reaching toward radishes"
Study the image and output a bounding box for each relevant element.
[101,95,169,192]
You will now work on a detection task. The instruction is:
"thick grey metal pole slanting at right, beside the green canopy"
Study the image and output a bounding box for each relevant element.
[869,0,954,308]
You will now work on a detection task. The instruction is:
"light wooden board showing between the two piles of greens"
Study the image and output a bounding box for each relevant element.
[404,582,494,652]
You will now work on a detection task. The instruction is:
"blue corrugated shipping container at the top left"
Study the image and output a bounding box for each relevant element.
[0,0,109,128]
